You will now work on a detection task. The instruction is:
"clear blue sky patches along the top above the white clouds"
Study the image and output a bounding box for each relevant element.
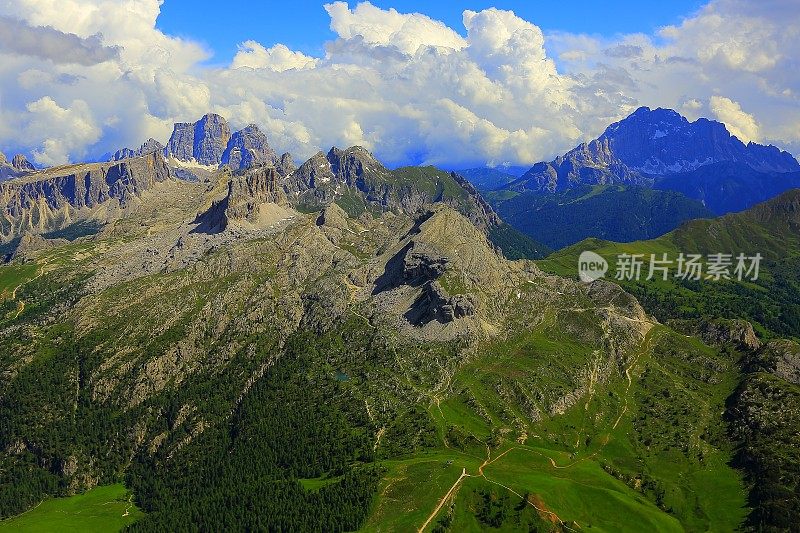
[157,0,705,63]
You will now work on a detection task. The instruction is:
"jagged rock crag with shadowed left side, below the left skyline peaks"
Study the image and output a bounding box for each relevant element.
[196,167,286,233]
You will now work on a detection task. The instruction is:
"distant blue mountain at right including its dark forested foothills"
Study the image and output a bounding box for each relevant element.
[465,107,800,248]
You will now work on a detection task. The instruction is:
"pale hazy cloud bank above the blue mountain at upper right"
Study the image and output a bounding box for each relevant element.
[549,0,800,154]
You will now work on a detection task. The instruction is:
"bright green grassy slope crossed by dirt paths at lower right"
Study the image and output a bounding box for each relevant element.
[365,328,747,531]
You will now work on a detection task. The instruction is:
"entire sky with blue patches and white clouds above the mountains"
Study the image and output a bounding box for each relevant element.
[0,0,800,168]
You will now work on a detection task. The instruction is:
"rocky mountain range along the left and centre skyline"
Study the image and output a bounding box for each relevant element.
[0,114,550,259]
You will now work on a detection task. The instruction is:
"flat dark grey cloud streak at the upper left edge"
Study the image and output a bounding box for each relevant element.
[0,16,119,65]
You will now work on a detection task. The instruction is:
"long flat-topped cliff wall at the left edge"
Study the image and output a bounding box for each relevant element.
[0,153,171,240]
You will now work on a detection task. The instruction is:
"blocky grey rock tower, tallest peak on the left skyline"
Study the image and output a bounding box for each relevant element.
[165,113,231,165]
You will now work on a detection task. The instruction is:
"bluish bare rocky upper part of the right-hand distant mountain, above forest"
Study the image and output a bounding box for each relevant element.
[511,107,800,191]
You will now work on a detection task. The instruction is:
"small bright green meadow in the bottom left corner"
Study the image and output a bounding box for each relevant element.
[0,485,142,533]
